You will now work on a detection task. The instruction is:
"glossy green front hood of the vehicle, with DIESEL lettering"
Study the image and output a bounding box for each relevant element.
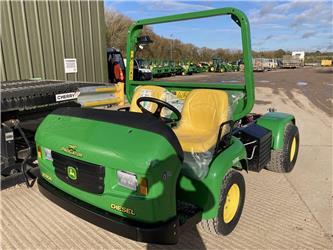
[36,114,181,222]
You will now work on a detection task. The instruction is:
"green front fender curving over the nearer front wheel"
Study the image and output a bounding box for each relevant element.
[177,137,247,219]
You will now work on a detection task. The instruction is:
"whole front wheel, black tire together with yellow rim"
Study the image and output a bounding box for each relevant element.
[200,170,245,235]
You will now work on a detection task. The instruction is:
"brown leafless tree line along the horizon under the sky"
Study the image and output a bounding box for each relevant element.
[105,9,333,63]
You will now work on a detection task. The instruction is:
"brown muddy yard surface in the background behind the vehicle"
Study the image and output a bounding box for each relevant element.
[154,68,333,117]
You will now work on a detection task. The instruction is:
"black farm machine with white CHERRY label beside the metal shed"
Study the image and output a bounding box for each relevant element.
[0,80,104,189]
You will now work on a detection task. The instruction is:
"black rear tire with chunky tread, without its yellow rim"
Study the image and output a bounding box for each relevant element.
[266,123,299,173]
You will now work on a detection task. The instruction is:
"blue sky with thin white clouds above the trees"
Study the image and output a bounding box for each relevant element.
[105,0,333,51]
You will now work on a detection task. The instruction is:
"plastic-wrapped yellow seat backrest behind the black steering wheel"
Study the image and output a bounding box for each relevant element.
[130,85,166,113]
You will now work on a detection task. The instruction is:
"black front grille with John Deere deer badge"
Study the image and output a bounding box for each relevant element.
[52,152,105,194]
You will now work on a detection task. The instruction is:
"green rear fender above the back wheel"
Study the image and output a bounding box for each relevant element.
[256,112,295,149]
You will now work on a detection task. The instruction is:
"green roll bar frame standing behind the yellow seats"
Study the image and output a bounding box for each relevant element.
[126,8,254,120]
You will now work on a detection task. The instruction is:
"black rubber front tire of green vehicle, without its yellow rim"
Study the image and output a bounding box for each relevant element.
[200,170,245,236]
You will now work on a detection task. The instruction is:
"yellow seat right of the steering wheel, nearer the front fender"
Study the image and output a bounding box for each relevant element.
[174,89,228,153]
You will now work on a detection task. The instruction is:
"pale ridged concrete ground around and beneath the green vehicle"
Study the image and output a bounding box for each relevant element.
[1,69,333,249]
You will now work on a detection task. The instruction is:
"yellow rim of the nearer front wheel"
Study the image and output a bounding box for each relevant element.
[223,184,240,223]
